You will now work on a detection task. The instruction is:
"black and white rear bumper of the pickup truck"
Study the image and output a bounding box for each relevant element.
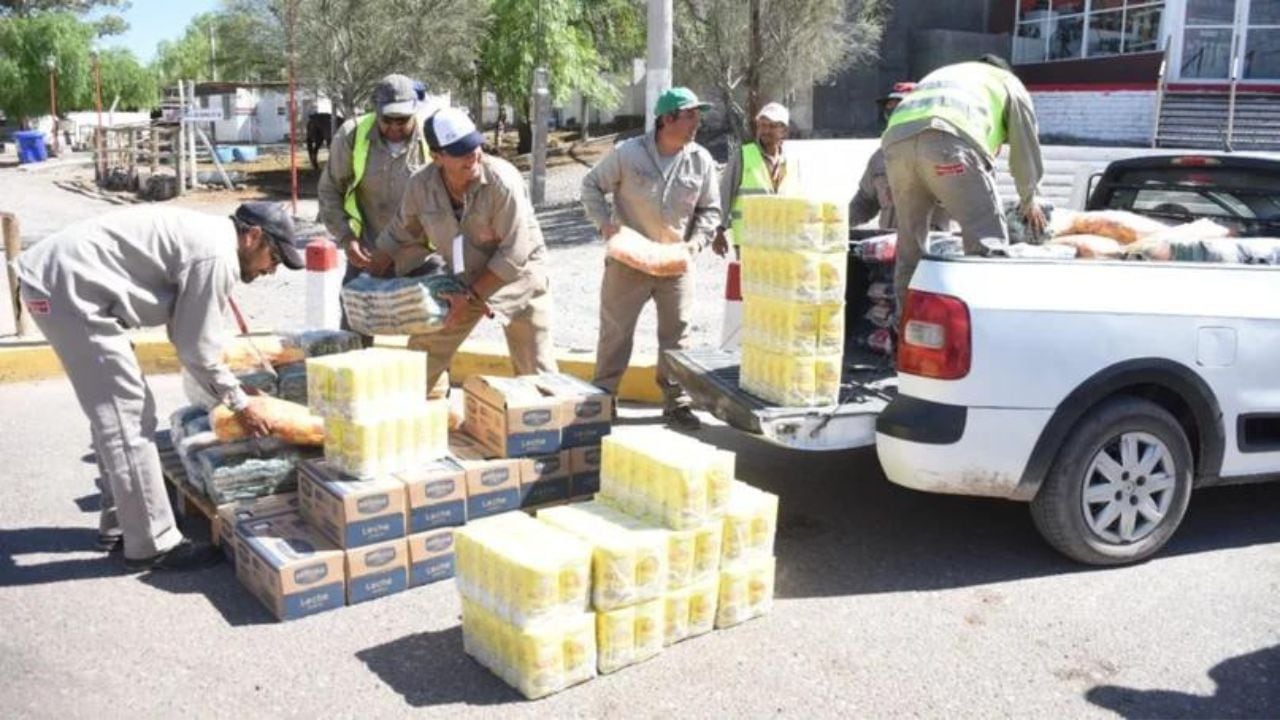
[876,396,1052,498]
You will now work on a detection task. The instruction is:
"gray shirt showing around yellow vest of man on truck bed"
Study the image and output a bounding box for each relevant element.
[881,73,1044,209]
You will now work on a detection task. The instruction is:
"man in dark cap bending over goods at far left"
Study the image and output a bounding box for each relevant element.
[15,202,302,570]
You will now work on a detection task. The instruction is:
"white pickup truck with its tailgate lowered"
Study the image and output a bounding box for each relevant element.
[671,156,1280,565]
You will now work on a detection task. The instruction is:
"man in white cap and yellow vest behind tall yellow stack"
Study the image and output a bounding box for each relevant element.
[712,102,800,256]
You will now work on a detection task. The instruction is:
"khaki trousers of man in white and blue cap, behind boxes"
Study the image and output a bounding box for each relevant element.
[408,286,558,397]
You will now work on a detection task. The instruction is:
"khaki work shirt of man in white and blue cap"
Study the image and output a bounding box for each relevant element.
[376,155,548,320]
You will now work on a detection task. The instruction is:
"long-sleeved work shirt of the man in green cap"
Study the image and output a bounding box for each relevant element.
[582,133,721,250]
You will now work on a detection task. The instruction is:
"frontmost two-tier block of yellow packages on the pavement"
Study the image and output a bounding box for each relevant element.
[454,511,596,700]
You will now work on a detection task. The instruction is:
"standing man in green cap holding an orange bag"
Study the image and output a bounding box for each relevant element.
[582,87,721,429]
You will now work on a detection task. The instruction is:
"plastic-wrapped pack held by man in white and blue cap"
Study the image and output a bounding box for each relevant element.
[342,273,466,334]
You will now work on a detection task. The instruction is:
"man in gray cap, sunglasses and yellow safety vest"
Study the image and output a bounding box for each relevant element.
[316,74,431,345]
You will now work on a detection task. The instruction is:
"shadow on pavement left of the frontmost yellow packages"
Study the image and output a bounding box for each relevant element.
[356,625,524,707]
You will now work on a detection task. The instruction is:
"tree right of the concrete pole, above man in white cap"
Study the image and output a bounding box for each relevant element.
[675,0,888,137]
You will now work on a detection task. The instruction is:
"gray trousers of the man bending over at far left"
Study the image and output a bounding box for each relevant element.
[22,286,182,560]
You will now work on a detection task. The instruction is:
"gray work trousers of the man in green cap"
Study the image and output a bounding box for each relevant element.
[591,259,694,411]
